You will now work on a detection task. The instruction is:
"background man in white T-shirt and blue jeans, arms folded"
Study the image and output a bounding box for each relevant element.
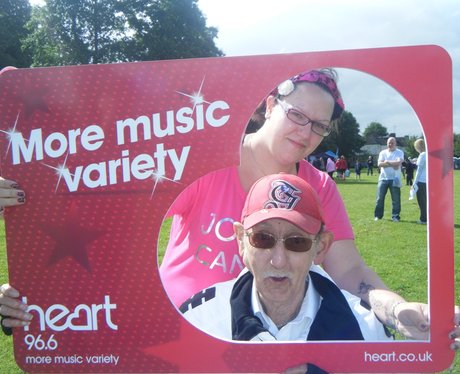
[374,137,404,222]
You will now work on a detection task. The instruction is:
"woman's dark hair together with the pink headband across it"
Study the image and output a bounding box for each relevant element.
[246,68,345,134]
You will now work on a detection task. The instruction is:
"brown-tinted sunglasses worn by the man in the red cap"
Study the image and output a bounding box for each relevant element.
[245,231,316,252]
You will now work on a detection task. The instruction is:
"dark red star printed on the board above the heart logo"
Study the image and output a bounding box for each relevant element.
[42,204,104,272]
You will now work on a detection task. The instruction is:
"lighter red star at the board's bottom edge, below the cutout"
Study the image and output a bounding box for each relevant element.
[144,318,231,373]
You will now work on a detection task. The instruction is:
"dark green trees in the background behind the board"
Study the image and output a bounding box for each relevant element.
[0,0,460,158]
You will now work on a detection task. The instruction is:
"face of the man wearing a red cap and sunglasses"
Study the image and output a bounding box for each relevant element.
[240,219,327,312]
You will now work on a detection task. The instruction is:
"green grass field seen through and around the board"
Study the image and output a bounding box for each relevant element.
[0,171,460,373]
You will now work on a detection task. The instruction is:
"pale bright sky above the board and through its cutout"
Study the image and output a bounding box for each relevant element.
[198,0,460,136]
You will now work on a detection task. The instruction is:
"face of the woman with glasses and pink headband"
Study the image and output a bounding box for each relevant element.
[260,83,334,165]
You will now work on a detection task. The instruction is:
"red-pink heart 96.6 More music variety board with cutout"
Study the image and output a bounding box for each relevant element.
[0,46,454,373]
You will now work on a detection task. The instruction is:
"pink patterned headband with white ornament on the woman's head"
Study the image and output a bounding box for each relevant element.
[272,70,345,120]
